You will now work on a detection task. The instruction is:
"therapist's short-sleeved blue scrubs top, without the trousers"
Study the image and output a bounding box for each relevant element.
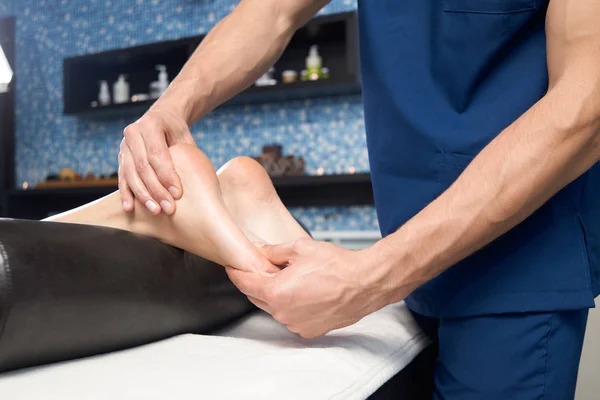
[359,0,600,317]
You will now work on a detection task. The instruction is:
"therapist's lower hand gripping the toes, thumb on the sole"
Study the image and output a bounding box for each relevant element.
[227,239,390,339]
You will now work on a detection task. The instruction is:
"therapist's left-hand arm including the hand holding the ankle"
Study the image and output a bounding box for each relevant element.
[119,0,330,214]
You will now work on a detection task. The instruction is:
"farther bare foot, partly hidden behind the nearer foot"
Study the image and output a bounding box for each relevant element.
[217,157,309,244]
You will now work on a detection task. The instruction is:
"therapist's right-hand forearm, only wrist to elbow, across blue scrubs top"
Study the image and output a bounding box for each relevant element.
[371,84,600,301]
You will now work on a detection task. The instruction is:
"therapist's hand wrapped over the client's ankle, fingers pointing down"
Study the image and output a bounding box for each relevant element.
[119,109,194,214]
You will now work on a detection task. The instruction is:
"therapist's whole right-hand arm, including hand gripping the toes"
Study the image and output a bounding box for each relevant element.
[227,0,600,338]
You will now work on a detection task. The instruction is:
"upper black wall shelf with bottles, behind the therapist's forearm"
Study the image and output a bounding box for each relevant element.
[63,12,360,118]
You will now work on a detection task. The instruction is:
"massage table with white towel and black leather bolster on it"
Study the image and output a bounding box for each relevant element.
[0,220,435,400]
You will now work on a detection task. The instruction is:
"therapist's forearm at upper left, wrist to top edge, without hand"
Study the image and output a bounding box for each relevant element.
[153,0,328,125]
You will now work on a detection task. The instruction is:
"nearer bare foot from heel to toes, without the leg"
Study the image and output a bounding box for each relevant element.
[166,145,272,271]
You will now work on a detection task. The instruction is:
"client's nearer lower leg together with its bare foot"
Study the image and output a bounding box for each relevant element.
[46,145,271,270]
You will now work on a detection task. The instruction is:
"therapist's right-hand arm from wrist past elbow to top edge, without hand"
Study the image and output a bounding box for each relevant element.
[369,0,600,301]
